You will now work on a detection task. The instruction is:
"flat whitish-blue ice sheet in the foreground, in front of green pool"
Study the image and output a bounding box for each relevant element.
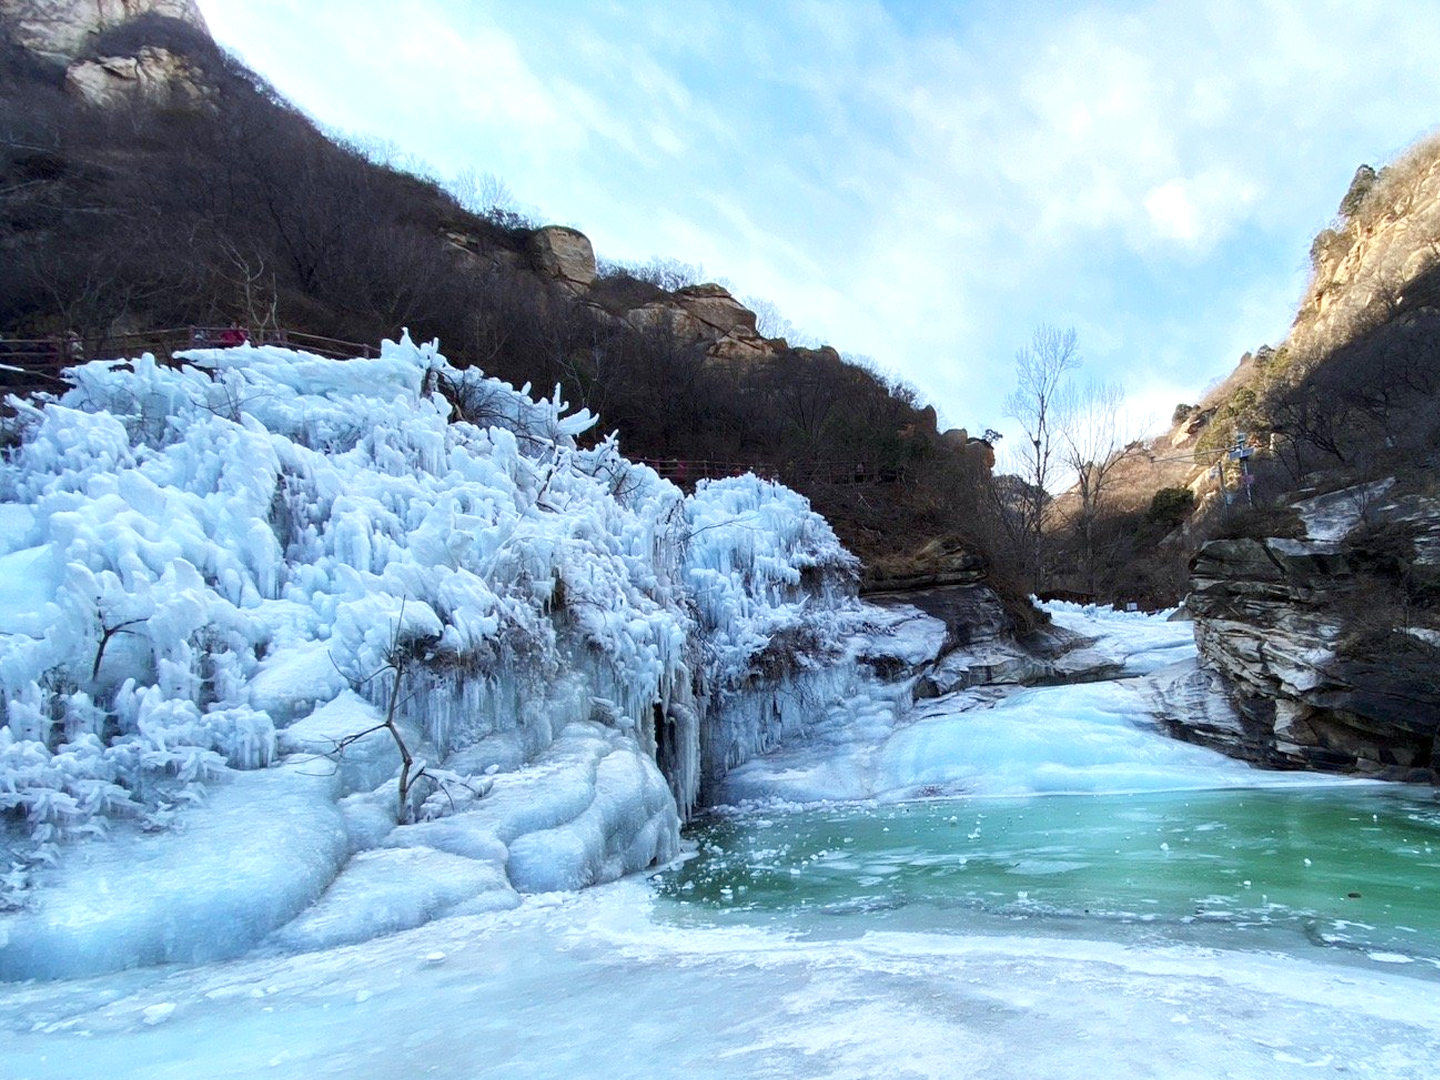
[0,881,1440,1080]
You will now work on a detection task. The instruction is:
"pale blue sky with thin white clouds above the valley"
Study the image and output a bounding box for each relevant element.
[200,0,1440,449]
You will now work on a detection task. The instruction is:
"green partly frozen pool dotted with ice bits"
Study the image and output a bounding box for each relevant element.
[658,785,1440,966]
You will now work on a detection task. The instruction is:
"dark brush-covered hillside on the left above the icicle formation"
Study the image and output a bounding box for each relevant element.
[0,16,1025,601]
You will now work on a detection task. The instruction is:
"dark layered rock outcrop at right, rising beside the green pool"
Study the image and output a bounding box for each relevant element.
[1169,498,1440,782]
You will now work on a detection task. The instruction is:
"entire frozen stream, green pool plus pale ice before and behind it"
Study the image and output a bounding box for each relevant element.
[0,604,1440,1080]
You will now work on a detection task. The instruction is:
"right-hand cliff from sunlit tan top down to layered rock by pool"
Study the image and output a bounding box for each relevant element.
[1171,138,1440,782]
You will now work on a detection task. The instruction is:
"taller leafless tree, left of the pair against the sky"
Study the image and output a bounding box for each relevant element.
[1005,325,1080,589]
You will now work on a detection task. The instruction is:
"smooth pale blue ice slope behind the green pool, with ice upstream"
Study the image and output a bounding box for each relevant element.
[721,603,1326,804]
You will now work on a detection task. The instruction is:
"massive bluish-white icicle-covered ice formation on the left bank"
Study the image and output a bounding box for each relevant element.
[0,338,857,978]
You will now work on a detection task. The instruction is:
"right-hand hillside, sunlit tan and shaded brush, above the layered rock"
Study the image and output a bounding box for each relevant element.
[1054,137,1440,603]
